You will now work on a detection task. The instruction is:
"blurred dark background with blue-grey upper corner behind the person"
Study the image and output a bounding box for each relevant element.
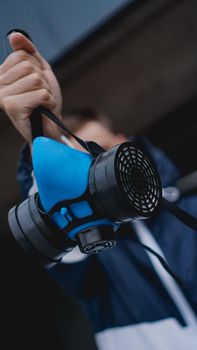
[0,0,197,350]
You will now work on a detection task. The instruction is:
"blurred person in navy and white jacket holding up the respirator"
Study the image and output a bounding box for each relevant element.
[0,33,197,350]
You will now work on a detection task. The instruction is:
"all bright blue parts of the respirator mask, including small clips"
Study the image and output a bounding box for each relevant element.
[32,137,117,238]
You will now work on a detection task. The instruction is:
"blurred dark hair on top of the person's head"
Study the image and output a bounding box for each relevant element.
[63,108,113,133]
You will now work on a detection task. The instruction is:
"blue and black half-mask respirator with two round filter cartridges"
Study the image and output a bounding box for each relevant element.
[8,108,161,262]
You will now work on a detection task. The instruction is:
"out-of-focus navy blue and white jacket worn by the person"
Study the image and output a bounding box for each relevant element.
[18,141,197,350]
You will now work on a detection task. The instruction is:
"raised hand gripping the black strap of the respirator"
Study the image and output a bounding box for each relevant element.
[0,33,62,143]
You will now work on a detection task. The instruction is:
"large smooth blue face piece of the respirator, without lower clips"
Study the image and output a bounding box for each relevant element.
[32,137,92,213]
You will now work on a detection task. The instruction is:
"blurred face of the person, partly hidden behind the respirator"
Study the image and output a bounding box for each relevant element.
[70,121,127,151]
